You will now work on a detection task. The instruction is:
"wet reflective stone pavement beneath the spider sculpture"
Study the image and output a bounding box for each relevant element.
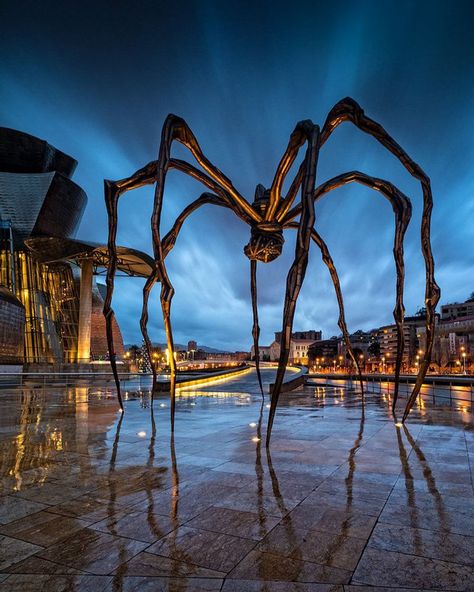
[0,370,474,592]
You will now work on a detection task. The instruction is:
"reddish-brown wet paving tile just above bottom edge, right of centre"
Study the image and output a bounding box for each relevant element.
[227,550,352,584]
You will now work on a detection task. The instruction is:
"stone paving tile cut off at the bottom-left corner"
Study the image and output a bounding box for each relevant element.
[0,574,112,592]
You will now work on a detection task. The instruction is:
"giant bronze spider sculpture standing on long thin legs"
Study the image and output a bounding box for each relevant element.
[104,98,440,445]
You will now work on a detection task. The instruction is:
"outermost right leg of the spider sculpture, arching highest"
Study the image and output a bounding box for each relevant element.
[321,98,440,422]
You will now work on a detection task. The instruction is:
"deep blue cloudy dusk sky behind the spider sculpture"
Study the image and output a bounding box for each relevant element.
[0,0,474,349]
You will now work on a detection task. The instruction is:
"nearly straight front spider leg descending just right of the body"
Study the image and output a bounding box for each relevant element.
[266,121,319,446]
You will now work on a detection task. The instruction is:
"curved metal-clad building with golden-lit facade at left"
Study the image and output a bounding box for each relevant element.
[0,128,152,364]
